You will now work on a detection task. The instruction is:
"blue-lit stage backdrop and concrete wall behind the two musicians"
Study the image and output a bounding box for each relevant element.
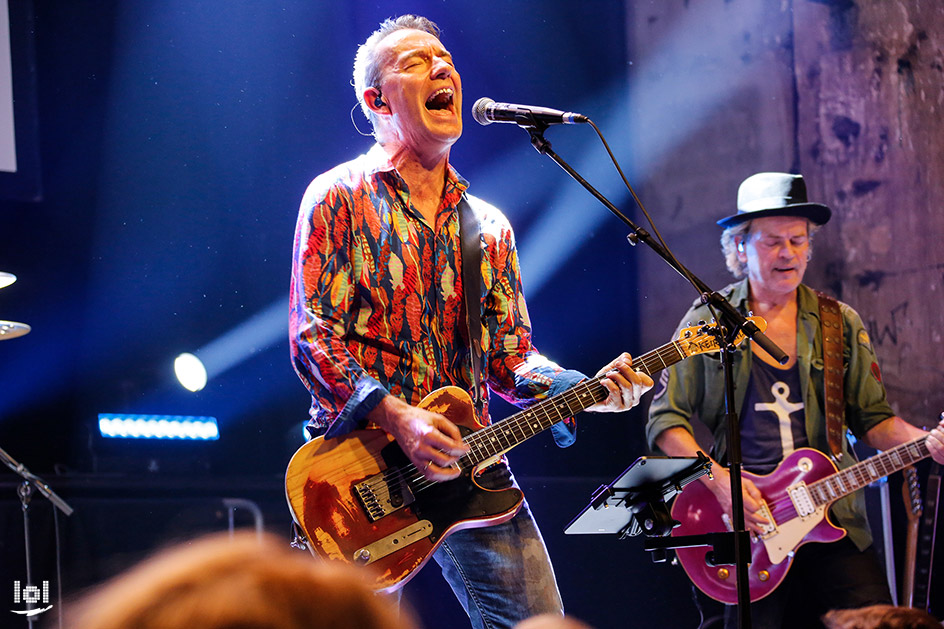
[0,0,944,628]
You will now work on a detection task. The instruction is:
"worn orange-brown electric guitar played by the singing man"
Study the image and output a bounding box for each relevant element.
[285,317,767,591]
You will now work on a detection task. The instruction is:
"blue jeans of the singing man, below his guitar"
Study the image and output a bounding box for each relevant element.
[433,465,564,629]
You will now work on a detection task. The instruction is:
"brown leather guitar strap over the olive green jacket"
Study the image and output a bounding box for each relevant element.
[816,291,846,461]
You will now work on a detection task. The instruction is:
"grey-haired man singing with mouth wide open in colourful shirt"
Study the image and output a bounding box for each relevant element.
[290,15,652,627]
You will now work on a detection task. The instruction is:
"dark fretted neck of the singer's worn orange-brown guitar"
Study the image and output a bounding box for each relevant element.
[459,341,690,468]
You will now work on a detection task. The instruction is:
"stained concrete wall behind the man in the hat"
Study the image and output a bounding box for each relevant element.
[629,0,944,425]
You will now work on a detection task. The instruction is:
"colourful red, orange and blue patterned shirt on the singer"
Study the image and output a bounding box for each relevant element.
[289,145,585,446]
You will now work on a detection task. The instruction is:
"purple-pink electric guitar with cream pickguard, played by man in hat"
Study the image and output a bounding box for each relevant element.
[672,437,931,605]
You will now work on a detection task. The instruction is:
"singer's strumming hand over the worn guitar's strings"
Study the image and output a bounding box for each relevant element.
[367,395,469,481]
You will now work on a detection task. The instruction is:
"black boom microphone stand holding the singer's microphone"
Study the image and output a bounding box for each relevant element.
[518,118,788,629]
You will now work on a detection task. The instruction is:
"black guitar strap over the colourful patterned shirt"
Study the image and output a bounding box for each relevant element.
[457,194,483,420]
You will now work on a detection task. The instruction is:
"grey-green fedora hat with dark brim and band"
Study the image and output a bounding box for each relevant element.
[718,173,832,228]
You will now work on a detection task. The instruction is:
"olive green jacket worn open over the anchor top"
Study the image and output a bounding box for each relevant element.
[646,280,895,549]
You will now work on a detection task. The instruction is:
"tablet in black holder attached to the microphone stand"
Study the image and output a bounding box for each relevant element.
[564,452,711,544]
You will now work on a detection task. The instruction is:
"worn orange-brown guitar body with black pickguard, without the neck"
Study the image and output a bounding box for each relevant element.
[285,387,523,591]
